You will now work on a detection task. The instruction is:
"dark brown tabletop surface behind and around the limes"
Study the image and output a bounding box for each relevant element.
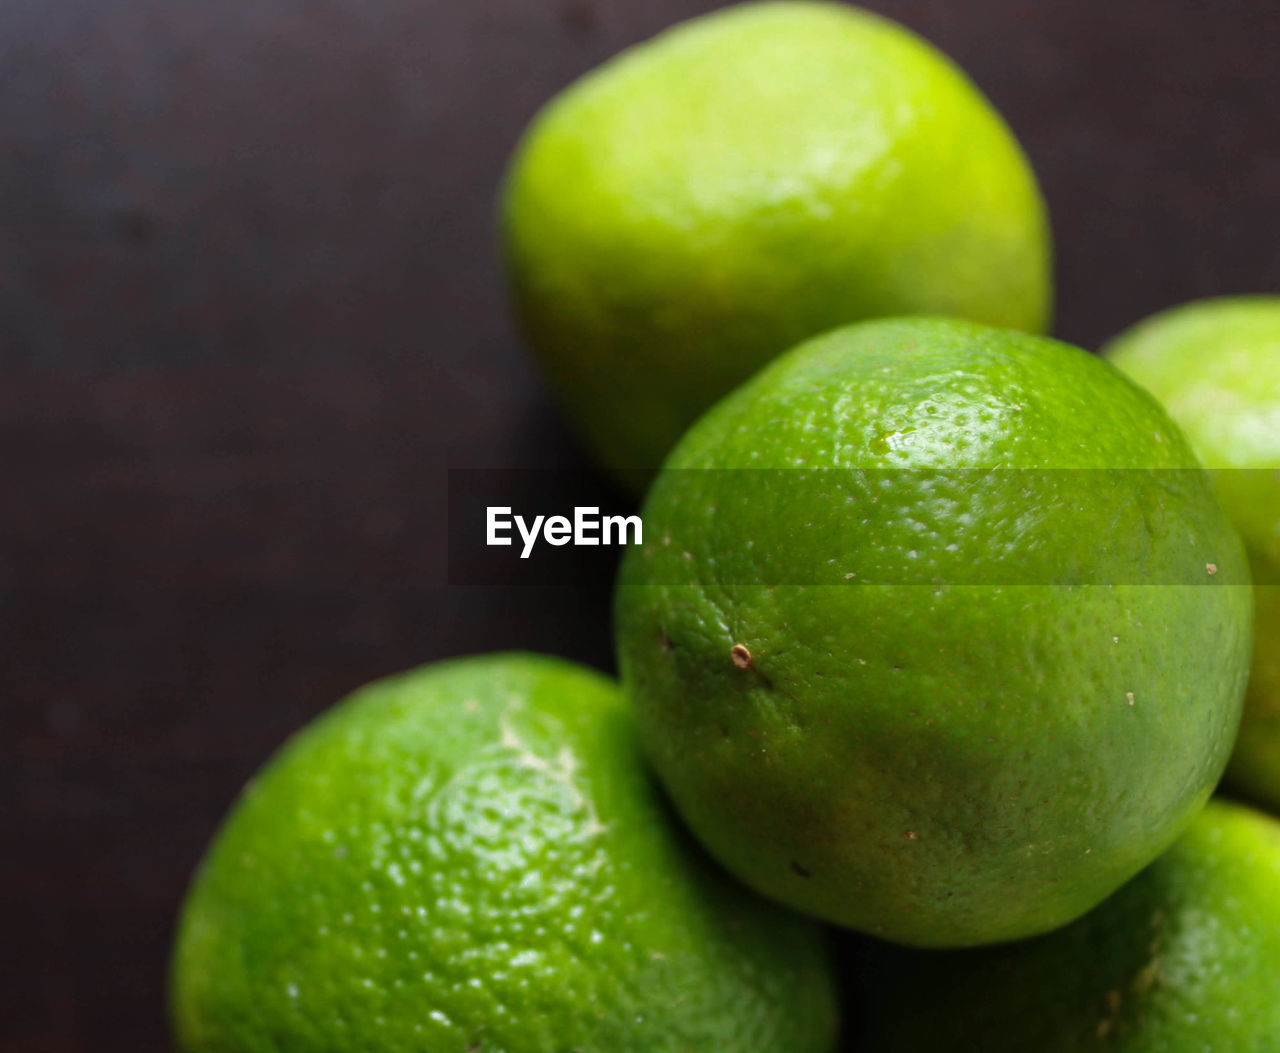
[0,0,1280,1053]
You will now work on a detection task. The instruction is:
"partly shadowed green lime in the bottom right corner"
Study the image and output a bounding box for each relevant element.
[864,801,1280,1053]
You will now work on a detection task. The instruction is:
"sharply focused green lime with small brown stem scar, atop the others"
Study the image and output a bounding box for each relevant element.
[616,319,1251,946]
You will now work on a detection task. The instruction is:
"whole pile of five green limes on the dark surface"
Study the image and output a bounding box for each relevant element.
[172,3,1280,1053]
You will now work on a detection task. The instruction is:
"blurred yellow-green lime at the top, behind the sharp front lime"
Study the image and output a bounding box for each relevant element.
[500,3,1051,486]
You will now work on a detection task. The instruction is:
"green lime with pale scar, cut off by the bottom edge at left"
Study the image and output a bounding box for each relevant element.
[173,655,835,1053]
